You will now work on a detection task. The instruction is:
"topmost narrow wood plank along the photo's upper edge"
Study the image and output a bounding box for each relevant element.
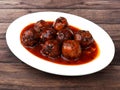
[0,0,120,9]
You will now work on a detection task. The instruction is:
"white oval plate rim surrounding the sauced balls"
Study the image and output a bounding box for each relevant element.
[6,12,115,76]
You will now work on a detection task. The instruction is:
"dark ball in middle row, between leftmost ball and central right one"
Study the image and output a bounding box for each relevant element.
[40,28,56,43]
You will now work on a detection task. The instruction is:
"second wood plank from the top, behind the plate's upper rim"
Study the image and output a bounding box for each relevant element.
[0,9,120,24]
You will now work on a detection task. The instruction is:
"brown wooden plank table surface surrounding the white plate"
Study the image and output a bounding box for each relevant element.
[0,0,120,90]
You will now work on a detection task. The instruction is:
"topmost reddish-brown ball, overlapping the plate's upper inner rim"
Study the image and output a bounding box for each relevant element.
[53,17,68,31]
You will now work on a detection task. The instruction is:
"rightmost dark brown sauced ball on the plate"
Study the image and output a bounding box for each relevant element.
[74,30,94,47]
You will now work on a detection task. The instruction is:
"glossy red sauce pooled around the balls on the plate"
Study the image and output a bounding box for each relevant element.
[20,22,99,65]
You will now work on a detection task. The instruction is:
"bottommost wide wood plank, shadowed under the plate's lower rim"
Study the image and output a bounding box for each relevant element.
[0,63,120,90]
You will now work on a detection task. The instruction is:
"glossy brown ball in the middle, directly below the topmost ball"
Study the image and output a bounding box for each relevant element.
[56,29,73,42]
